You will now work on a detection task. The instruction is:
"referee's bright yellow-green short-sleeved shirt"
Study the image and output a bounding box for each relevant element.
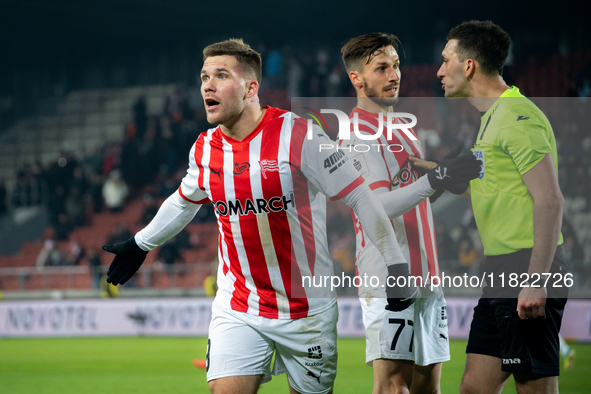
[470,86,562,256]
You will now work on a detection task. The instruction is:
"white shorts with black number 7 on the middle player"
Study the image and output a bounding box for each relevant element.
[360,297,449,366]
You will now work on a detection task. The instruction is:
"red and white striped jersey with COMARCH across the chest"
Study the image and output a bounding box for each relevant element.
[179,107,363,319]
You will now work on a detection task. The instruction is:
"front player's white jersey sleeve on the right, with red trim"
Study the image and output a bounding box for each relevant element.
[292,119,363,200]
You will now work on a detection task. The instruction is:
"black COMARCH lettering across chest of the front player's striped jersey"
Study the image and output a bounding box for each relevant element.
[213,192,295,216]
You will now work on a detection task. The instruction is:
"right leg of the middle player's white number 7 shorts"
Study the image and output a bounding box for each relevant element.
[413,297,450,366]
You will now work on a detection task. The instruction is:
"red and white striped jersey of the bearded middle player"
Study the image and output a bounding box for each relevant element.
[340,107,439,296]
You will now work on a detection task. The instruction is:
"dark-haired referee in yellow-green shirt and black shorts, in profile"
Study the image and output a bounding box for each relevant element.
[430,21,568,394]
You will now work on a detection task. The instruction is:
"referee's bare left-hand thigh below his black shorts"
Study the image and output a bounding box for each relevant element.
[460,353,511,394]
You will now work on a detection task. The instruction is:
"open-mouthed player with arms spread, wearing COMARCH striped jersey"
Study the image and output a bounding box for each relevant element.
[105,39,414,393]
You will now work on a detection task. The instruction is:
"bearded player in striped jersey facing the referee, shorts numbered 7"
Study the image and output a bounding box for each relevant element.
[341,33,480,393]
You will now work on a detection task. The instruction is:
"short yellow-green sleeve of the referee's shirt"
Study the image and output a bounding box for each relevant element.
[499,120,552,175]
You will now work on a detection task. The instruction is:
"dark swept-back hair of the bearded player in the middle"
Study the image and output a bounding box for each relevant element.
[341,33,400,72]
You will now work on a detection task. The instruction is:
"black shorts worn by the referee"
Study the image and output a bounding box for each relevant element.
[466,248,568,376]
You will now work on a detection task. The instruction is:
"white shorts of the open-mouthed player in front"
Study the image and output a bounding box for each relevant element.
[207,302,338,393]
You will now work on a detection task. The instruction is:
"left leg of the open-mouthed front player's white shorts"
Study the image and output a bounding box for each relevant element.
[207,304,274,383]
